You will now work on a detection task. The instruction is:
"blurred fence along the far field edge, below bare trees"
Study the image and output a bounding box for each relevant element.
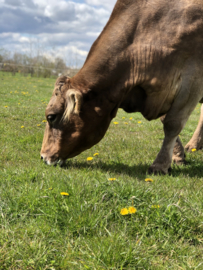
[0,62,79,78]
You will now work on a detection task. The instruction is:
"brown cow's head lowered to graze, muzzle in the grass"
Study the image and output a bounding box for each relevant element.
[41,77,118,165]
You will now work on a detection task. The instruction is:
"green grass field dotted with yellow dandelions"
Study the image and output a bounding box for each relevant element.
[0,72,203,270]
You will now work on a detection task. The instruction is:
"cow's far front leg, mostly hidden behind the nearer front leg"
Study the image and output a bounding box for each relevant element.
[160,115,186,165]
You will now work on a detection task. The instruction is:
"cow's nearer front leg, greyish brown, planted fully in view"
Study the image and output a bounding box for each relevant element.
[149,73,203,174]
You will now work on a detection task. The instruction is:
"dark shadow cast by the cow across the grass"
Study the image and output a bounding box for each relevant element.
[63,160,203,181]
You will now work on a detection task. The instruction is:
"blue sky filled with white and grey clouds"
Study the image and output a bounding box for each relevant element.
[0,0,116,67]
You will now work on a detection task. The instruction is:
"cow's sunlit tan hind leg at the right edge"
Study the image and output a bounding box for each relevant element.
[185,104,203,152]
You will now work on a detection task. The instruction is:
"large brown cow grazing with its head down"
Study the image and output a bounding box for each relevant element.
[41,0,203,174]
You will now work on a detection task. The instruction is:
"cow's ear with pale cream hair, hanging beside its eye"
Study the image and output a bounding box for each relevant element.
[64,89,83,119]
